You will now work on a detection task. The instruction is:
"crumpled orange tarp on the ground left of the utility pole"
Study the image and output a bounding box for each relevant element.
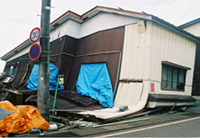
[0,101,49,137]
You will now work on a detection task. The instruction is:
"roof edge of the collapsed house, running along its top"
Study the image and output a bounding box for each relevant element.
[1,6,199,61]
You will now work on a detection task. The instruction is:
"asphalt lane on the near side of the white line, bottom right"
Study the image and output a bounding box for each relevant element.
[93,116,200,138]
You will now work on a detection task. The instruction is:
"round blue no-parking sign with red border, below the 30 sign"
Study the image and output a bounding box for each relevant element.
[29,44,41,60]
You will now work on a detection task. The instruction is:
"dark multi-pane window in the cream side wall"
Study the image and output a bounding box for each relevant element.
[161,64,186,91]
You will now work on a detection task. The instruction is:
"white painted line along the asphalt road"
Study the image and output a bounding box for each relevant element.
[95,116,200,138]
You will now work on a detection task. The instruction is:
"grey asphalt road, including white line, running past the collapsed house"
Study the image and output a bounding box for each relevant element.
[15,104,200,138]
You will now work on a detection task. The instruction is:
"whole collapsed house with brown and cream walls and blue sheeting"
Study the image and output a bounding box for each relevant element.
[0,6,199,120]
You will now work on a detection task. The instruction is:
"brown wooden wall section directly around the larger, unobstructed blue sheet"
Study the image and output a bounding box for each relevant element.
[65,27,124,93]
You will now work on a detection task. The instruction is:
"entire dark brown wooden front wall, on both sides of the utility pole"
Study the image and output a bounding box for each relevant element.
[5,27,124,93]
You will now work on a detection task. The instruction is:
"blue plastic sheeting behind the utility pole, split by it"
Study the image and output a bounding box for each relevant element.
[27,62,64,90]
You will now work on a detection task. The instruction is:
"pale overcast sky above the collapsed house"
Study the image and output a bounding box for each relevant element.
[0,0,200,72]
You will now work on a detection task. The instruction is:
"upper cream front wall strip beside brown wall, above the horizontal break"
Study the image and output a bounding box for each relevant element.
[120,21,151,81]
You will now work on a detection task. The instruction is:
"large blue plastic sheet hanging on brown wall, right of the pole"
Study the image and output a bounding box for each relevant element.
[76,63,113,107]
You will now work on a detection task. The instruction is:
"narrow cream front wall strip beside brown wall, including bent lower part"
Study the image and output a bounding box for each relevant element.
[114,21,151,109]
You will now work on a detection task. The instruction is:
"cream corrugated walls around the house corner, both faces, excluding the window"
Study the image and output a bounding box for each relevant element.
[115,21,196,106]
